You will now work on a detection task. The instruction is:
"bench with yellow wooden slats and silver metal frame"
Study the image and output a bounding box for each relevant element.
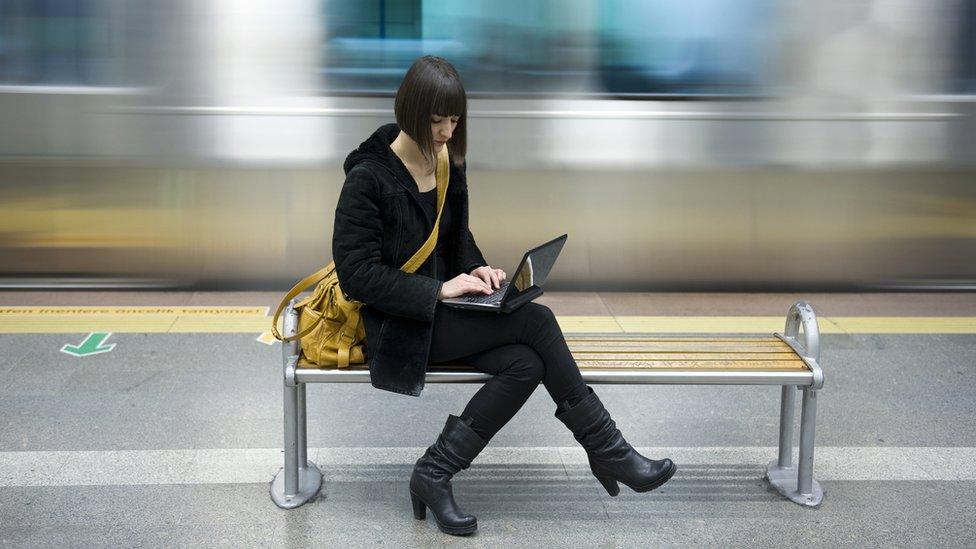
[271,300,823,509]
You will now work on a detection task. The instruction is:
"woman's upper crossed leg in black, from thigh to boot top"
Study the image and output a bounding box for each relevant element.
[430,303,588,408]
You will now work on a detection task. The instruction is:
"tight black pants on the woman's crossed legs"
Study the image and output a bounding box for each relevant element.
[429,303,587,440]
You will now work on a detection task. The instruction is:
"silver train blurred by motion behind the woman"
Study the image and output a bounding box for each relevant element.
[0,0,976,291]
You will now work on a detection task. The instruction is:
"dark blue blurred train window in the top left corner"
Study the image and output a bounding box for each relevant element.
[0,0,137,86]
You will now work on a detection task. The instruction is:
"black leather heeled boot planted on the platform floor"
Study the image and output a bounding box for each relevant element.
[410,415,488,535]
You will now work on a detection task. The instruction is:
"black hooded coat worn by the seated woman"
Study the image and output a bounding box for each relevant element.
[332,124,487,396]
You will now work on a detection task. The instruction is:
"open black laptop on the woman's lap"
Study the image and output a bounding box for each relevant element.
[441,234,568,313]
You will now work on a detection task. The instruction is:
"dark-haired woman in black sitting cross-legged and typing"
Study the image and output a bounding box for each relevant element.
[332,56,675,534]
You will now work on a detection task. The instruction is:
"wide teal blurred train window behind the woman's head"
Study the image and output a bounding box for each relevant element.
[321,0,774,97]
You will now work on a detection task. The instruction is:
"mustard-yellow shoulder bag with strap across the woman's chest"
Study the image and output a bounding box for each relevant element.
[271,147,450,368]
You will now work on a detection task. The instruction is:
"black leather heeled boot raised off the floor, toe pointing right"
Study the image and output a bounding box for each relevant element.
[556,387,678,496]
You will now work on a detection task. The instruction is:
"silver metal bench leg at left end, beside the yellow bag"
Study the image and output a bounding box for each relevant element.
[271,306,322,509]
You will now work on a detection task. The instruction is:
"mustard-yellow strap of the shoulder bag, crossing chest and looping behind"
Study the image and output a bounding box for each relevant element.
[271,146,451,342]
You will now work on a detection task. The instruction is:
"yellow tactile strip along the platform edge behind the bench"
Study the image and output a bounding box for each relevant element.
[0,306,976,334]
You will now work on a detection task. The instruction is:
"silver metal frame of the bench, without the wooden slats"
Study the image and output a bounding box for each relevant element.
[271,300,823,509]
